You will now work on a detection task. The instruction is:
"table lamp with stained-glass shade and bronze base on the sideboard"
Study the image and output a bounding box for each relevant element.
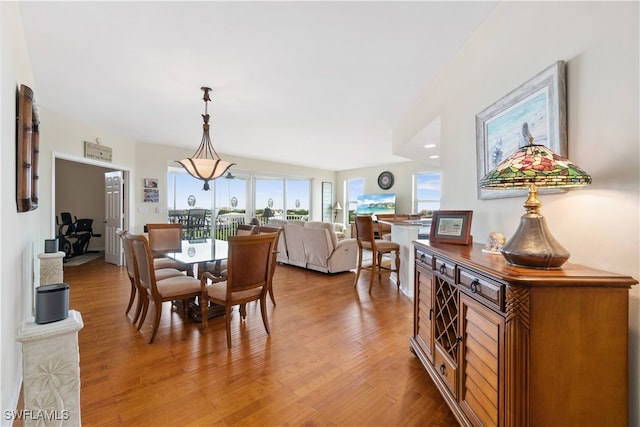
[480,138,591,268]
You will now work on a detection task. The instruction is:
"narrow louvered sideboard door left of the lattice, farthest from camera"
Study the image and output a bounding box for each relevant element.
[414,266,433,363]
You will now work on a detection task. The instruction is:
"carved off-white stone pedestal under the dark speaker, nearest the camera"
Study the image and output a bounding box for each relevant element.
[17,310,84,426]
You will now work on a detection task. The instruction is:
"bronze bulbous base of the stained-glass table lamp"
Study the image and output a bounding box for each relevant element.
[501,213,569,269]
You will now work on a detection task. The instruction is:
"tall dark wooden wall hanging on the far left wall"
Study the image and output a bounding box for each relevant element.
[16,85,40,212]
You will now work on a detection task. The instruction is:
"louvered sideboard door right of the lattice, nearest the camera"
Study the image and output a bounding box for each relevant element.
[458,292,504,426]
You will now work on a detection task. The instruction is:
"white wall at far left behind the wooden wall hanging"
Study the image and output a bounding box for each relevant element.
[0,2,44,425]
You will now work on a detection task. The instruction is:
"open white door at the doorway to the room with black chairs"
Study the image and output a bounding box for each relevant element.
[104,171,124,265]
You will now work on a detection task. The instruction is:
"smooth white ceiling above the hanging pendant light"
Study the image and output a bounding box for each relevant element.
[20,1,495,170]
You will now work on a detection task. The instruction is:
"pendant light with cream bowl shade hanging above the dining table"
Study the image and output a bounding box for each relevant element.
[178,87,235,191]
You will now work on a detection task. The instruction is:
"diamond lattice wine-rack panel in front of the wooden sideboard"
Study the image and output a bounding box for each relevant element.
[435,276,458,362]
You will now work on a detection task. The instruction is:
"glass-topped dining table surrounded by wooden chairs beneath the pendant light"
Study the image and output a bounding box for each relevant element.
[154,239,229,322]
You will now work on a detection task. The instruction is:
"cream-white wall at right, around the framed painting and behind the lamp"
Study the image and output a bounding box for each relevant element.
[394,2,640,425]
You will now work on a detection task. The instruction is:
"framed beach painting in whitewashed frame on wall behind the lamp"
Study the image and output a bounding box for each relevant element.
[476,61,567,199]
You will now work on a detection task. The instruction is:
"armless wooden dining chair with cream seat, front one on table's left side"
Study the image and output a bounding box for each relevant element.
[126,233,203,344]
